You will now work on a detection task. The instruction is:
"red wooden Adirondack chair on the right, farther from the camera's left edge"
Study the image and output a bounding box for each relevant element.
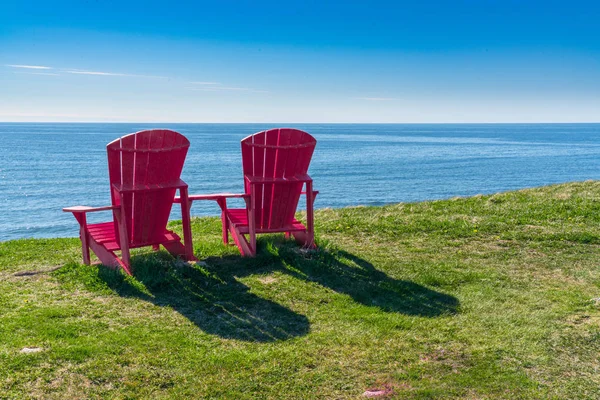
[175,128,319,256]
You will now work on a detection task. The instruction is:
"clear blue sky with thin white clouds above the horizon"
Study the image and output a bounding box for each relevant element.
[0,0,600,122]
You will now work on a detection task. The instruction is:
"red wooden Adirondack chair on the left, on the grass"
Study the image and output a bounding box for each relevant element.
[63,129,195,275]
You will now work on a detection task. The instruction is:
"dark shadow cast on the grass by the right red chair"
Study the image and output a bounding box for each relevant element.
[205,236,459,317]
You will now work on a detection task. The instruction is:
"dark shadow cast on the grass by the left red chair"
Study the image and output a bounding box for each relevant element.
[98,251,310,342]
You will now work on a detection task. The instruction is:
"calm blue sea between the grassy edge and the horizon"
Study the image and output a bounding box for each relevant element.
[0,123,600,241]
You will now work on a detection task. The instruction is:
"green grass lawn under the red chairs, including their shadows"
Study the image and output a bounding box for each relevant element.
[0,182,600,399]
